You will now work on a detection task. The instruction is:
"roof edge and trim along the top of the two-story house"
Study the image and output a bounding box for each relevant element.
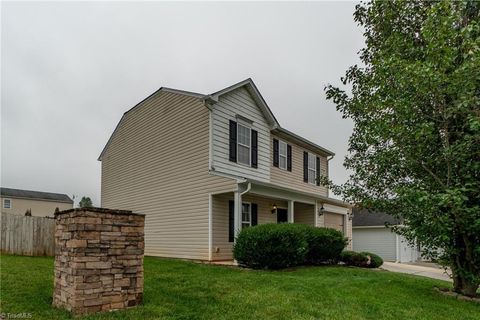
[97,78,335,161]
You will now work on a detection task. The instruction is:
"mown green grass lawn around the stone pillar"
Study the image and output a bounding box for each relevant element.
[1,256,480,320]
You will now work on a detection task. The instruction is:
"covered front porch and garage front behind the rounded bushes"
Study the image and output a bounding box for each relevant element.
[209,181,352,261]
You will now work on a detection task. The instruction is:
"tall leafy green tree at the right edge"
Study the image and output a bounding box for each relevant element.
[326,1,480,296]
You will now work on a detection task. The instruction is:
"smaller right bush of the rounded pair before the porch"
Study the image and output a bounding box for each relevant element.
[305,226,347,265]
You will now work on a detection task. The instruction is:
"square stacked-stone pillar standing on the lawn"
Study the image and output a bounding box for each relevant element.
[53,208,145,314]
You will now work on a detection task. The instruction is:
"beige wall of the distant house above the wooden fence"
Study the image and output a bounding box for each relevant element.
[0,197,73,217]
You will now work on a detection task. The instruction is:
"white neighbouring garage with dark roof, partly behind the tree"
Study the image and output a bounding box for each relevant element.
[352,209,421,262]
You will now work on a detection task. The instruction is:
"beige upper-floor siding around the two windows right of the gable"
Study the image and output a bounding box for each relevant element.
[270,135,328,196]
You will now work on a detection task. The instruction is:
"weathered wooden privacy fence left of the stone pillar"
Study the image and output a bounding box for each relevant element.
[0,212,55,256]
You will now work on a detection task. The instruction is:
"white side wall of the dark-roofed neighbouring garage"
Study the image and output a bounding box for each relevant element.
[353,228,397,261]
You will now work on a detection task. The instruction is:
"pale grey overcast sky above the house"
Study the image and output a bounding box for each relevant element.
[1,2,363,205]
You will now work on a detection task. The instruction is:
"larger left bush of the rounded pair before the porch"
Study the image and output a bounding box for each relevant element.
[233,223,308,269]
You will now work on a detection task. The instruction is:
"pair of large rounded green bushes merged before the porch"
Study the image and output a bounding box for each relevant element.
[233,223,347,269]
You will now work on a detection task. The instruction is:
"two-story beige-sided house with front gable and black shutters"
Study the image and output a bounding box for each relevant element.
[98,79,352,260]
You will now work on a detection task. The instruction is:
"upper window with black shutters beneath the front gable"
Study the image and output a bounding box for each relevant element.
[229,120,258,168]
